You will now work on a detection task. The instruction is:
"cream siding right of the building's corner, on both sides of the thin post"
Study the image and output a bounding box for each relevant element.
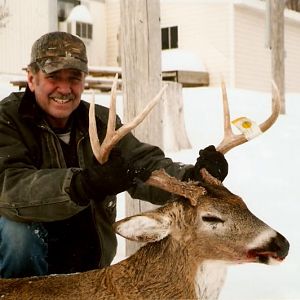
[234,4,300,92]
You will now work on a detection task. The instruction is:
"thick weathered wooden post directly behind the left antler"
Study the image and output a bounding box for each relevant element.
[120,0,163,255]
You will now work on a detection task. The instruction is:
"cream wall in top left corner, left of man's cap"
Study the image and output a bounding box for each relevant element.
[0,0,57,75]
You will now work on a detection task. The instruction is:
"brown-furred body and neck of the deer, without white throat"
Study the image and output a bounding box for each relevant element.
[0,241,223,300]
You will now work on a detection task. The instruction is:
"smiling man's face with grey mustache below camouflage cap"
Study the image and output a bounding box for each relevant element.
[28,69,85,128]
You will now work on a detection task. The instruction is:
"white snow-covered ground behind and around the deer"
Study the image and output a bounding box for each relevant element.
[0,80,300,300]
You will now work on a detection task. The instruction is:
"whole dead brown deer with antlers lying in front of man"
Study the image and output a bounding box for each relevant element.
[0,78,289,300]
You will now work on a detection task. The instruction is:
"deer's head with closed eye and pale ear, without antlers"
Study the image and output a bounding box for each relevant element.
[114,170,289,264]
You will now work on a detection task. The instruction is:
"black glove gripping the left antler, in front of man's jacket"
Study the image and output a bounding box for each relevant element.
[70,151,150,206]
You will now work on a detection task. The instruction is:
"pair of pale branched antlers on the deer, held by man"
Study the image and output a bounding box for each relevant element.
[89,74,280,205]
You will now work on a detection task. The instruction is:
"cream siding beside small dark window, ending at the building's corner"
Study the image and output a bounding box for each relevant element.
[161,0,232,86]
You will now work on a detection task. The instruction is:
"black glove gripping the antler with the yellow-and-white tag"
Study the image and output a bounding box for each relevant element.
[184,145,228,181]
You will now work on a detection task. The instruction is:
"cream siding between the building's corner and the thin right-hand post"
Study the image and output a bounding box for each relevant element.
[233,6,271,91]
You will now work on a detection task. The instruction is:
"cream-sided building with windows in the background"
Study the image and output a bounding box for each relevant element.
[0,0,300,92]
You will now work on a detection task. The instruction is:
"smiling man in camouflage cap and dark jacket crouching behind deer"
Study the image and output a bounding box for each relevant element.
[0,32,227,278]
